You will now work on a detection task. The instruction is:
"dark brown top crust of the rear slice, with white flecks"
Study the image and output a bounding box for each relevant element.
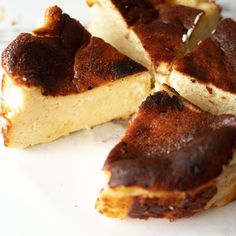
[112,0,204,65]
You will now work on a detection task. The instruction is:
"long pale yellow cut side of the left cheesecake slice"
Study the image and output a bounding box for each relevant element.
[3,72,151,148]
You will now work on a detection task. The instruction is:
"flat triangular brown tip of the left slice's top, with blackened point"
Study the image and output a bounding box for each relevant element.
[73,37,146,91]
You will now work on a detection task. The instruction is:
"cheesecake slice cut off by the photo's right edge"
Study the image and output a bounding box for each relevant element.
[167,19,236,114]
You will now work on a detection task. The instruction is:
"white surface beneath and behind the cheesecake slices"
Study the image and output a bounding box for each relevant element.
[0,0,236,236]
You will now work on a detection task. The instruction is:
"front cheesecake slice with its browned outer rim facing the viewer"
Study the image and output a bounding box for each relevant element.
[96,87,236,220]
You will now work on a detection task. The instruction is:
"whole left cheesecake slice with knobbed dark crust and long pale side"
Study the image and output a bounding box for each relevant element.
[2,6,151,148]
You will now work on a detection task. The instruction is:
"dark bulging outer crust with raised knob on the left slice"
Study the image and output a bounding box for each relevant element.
[2,7,90,95]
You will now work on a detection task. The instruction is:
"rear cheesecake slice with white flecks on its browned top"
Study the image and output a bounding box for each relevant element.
[87,0,220,83]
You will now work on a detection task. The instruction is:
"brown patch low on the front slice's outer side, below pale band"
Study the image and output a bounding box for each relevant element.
[128,186,217,220]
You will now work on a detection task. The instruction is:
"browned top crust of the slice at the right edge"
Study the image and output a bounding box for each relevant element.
[174,19,236,94]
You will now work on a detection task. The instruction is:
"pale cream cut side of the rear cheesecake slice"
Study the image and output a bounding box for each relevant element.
[88,0,152,69]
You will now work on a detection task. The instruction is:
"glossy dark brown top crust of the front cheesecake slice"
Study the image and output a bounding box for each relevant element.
[104,92,236,191]
